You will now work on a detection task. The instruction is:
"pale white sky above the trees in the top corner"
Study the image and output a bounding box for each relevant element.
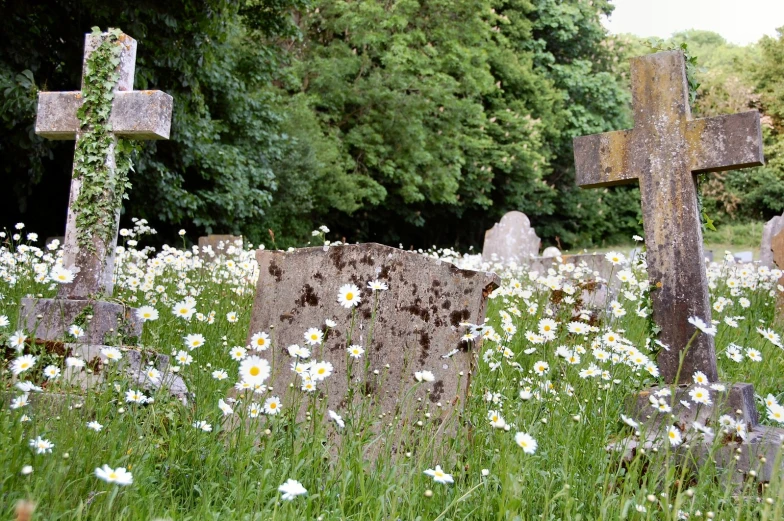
[605,0,784,45]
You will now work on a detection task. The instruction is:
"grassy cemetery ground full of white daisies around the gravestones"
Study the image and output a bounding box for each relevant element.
[0,221,784,520]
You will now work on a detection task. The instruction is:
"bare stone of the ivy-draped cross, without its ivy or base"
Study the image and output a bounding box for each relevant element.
[35,30,173,299]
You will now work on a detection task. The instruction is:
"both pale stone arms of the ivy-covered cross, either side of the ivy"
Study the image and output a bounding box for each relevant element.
[35,90,173,139]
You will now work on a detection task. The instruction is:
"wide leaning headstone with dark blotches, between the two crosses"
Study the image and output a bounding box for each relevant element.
[249,244,499,414]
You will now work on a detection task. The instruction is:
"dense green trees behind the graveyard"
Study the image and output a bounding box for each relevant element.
[0,0,784,247]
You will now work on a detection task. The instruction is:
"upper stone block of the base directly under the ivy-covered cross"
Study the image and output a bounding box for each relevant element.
[19,298,142,344]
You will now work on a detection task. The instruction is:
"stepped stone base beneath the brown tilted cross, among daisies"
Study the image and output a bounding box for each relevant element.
[608,383,784,485]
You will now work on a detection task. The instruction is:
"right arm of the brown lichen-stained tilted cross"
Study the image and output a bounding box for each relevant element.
[686,110,765,173]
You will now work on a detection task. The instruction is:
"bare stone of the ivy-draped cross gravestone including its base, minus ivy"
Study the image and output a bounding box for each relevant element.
[19,29,178,394]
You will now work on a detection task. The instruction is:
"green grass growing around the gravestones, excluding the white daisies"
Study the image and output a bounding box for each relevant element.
[0,221,784,520]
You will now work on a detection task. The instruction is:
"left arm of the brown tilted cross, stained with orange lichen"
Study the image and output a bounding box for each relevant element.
[574,130,638,188]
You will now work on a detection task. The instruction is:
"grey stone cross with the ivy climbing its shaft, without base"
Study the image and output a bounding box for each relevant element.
[35,29,173,299]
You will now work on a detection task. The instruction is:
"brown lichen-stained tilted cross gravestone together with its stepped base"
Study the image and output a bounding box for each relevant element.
[574,51,784,482]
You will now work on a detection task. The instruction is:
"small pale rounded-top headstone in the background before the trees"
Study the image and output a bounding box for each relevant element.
[482,212,542,263]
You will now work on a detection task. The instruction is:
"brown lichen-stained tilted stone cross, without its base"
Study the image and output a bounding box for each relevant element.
[574,51,763,383]
